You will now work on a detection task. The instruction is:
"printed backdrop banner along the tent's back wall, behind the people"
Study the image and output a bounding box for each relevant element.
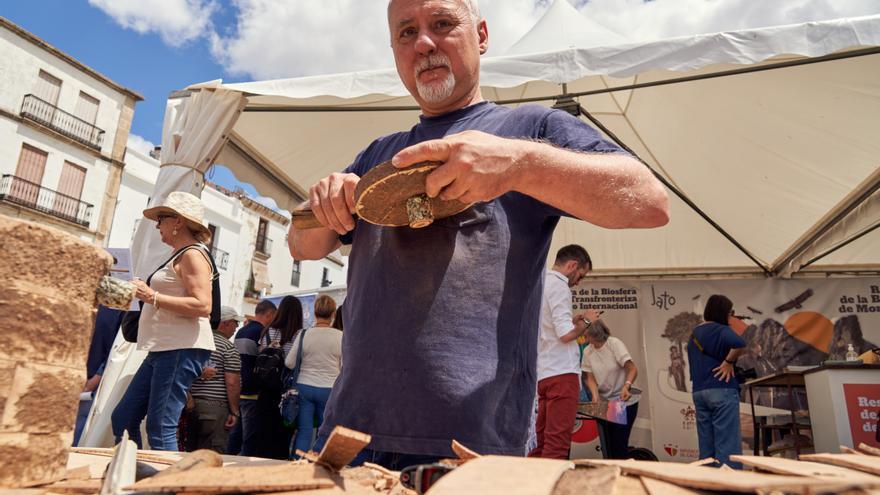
[572,278,880,462]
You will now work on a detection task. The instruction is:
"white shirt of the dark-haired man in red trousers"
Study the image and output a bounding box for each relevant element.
[538,270,580,380]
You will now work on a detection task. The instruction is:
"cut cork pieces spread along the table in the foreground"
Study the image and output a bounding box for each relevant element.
[6,427,880,495]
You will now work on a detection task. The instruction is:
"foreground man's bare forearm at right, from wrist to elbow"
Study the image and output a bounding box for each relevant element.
[513,141,669,228]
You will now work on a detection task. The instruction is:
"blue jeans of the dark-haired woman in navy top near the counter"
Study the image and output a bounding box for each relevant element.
[693,388,742,469]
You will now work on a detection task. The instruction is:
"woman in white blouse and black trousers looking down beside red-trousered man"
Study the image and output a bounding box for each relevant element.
[581,320,639,459]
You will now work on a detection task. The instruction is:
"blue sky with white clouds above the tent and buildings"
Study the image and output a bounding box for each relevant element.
[0,0,880,203]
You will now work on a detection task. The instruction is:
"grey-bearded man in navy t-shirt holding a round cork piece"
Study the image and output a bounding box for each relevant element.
[288,0,668,469]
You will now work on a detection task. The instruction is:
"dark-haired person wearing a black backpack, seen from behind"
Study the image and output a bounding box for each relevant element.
[252,296,303,459]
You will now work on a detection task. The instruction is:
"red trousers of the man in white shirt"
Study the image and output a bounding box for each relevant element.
[529,373,580,459]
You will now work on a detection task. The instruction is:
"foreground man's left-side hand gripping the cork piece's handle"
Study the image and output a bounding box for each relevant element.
[309,173,361,235]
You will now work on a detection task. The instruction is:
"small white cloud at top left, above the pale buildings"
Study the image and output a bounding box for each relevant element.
[89,0,218,46]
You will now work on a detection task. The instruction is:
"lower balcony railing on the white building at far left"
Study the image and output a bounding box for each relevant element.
[0,174,93,227]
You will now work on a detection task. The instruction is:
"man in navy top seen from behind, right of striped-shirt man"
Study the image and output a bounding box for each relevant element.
[226,300,277,456]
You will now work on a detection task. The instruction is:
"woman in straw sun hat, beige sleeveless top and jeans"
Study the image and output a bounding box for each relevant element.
[111,191,214,450]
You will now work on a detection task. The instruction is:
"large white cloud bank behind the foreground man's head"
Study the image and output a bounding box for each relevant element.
[208,0,880,79]
